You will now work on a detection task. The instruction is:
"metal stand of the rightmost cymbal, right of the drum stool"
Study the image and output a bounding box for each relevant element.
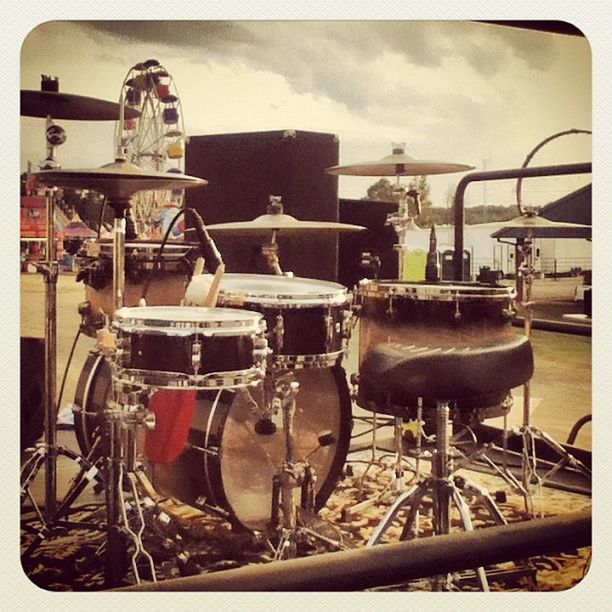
[512,232,591,516]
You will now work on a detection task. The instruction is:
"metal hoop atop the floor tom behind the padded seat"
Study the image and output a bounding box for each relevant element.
[358,282,516,302]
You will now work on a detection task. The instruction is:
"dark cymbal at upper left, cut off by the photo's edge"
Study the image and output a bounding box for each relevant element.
[21,89,140,121]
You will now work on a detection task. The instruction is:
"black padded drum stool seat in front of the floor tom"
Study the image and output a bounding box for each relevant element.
[357,335,533,406]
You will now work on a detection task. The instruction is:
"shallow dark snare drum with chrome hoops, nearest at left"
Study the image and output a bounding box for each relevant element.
[111,306,268,389]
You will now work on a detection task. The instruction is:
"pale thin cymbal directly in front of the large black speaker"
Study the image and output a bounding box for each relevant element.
[206,213,366,235]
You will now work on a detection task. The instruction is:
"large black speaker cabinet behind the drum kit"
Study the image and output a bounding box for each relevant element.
[185,130,339,281]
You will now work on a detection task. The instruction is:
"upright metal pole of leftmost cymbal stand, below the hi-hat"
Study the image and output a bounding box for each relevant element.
[42,189,58,518]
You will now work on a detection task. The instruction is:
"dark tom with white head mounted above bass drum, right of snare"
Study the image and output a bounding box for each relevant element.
[217,274,351,370]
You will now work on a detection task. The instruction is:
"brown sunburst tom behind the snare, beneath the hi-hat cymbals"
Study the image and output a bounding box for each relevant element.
[77,240,200,337]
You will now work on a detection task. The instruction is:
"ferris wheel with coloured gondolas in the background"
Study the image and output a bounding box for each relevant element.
[115,59,185,239]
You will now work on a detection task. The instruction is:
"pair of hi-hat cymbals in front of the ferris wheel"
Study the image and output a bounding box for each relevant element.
[35,160,208,200]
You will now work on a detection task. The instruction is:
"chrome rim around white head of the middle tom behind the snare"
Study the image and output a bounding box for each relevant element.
[219,272,350,308]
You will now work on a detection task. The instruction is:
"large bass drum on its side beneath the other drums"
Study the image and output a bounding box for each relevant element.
[75,354,351,530]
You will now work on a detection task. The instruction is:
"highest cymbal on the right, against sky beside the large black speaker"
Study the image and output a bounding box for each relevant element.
[326,146,474,176]
